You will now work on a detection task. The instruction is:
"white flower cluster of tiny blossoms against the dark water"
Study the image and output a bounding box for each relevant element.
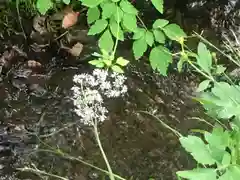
[72,69,127,125]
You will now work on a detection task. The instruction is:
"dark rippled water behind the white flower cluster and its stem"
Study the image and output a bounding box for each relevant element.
[0,1,239,180]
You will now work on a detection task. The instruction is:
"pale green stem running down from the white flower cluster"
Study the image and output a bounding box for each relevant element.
[93,123,115,180]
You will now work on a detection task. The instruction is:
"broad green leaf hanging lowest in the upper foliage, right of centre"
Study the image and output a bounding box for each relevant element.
[149,46,172,76]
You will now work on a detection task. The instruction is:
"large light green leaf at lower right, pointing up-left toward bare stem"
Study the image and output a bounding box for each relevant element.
[179,135,215,165]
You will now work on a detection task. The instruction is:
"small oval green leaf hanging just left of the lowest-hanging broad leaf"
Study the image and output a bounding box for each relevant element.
[133,37,147,59]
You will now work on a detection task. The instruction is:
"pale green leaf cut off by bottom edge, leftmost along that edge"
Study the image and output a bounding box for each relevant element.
[177,168,217,180]
